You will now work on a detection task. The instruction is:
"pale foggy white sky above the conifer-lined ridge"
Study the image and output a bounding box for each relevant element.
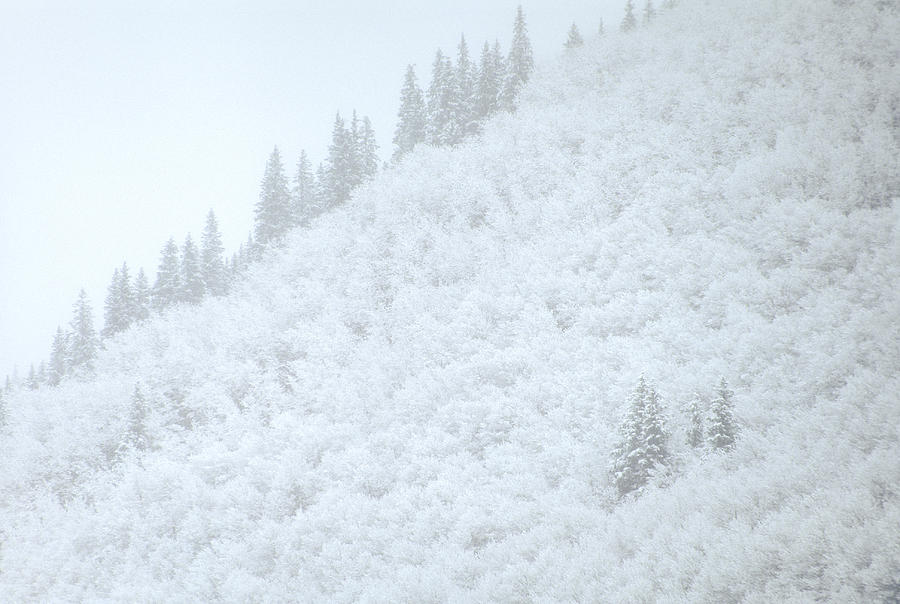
[0,0,624,380]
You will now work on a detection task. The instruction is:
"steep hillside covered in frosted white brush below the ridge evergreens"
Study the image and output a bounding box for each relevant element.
[0,0,900,602]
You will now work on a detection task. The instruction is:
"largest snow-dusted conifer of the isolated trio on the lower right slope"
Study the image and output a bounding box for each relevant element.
[610,376,669,496]
